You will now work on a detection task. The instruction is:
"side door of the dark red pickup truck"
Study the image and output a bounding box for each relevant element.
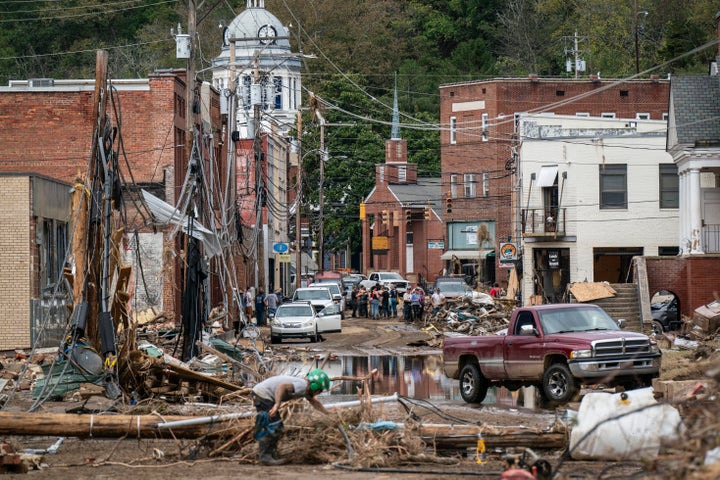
[503,311,543,380]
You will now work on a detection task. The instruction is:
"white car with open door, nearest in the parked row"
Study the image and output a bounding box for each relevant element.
[270,302,342,343]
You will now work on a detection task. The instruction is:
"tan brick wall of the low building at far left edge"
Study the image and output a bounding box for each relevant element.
[0,176,31,350]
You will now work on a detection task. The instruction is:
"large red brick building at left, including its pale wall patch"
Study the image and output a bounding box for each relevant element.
[0,70,232,348]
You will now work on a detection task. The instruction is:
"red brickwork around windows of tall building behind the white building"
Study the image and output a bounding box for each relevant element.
[440,79,670,280]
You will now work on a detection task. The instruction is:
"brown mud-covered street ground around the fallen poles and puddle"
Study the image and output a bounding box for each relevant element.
[0,318,720,480]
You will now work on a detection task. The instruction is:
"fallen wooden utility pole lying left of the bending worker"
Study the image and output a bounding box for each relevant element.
[0,412,255,438]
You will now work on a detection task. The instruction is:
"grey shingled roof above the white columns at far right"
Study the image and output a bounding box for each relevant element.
[668,76,720,145]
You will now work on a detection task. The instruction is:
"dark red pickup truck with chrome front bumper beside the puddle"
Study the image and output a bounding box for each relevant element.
[443,303,661,405]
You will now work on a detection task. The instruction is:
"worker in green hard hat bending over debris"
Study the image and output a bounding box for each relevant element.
[252,368,330,465]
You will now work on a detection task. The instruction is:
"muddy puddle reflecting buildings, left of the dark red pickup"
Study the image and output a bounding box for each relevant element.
[276,355,536,406]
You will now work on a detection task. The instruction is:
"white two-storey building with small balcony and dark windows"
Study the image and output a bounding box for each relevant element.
[517,114,679,303]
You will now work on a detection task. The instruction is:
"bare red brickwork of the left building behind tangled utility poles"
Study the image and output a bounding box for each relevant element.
[0,70,232,349]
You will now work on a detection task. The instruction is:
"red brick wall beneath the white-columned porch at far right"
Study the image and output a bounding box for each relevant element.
[646,255,720,317]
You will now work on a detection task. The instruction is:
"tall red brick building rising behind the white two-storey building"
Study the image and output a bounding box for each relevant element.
[440,76,669,282]
